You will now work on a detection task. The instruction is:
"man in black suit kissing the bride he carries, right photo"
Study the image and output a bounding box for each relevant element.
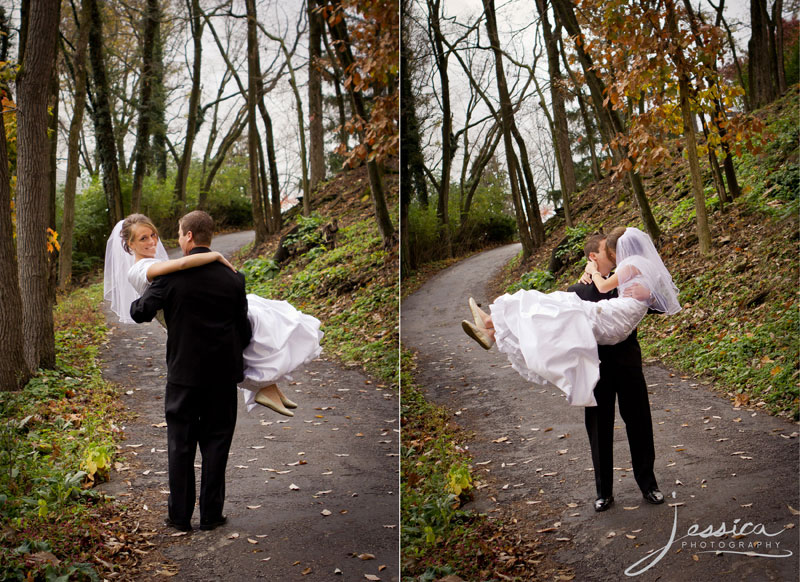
[568,235,664,511]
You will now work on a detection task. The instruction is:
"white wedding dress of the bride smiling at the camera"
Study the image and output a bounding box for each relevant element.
[126,258,323,412]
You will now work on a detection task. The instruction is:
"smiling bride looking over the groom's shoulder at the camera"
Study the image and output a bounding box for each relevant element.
[103,214,323,416]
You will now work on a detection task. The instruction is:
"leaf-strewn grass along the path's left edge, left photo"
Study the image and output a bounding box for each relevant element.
[0,285,120,580]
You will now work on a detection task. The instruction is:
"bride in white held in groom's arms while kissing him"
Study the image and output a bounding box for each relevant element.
[461,227,681,406]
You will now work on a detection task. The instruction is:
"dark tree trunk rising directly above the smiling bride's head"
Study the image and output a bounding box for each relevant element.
[131,0,161,212]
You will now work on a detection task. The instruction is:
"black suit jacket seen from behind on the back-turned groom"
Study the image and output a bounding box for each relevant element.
[131,247,252,386]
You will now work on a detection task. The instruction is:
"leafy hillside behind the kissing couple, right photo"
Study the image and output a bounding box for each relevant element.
[495,86,800,419]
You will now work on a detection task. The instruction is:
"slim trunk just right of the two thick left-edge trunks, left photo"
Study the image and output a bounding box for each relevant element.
[58,0,91,289]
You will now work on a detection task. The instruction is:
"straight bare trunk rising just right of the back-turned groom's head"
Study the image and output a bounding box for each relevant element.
[246,0,267,247]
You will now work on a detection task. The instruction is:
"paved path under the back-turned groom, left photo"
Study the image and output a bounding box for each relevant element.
[103,233,399,582]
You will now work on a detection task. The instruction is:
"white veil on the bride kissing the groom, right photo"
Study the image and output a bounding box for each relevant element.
[616,227,681,315]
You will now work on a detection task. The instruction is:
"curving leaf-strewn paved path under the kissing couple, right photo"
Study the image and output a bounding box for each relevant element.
[401,245,800,582]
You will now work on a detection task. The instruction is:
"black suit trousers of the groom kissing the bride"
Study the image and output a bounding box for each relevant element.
[586,363,658,497]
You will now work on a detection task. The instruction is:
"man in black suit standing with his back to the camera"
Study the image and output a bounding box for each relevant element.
[131,210,251,531]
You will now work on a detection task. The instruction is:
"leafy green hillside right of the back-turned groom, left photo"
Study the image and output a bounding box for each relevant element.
[237,163,399,386]
